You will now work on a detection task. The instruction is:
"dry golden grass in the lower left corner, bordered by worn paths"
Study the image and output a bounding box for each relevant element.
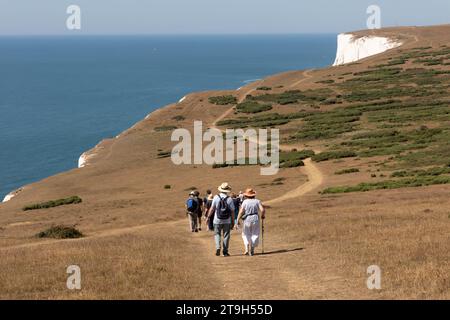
[0,224,218,299]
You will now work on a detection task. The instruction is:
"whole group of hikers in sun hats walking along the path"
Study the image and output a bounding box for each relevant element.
[186,182,266,257]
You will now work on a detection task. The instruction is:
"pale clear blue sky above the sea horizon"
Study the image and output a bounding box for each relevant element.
[0,0,450,35]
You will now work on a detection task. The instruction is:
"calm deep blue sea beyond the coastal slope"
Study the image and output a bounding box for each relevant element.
[0,34,336,201]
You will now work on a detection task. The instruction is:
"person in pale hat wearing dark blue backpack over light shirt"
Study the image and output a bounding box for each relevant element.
[208,182,234,257]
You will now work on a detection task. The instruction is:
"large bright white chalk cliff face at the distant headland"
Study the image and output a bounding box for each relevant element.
[333,33,402,66]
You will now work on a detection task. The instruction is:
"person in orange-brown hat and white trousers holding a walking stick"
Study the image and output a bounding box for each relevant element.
[238,188,266,256]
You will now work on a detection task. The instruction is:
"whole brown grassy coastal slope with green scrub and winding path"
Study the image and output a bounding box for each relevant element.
[0,25,450,299]
